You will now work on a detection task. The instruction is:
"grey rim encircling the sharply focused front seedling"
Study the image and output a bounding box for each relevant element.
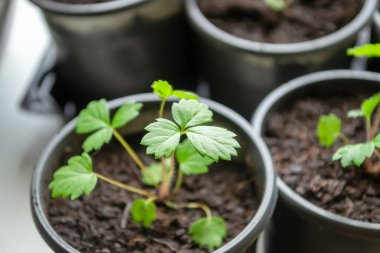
[31,93,277,253]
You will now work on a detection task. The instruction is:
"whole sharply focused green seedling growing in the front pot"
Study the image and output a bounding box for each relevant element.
[49,81,240,250]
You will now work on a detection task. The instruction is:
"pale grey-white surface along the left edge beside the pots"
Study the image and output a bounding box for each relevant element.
[0,0,61,253]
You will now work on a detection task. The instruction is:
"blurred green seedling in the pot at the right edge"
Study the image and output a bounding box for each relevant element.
[317,93,380,173]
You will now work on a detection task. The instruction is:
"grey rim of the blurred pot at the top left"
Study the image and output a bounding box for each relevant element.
[30,0,148,15]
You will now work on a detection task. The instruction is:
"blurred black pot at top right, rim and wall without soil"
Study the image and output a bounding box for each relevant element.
[186,0,377,117]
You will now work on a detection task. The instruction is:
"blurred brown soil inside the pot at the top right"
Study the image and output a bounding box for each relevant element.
[198,0,363,43]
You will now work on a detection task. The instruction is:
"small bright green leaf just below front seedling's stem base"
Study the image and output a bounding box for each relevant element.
[131,199,157,228]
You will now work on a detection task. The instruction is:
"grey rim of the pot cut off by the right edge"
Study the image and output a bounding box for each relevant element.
[251,70,380,235]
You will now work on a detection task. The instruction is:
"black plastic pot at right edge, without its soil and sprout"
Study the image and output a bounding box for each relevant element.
[252,70,380,253]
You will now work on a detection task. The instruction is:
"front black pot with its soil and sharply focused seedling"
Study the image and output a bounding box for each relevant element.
[32,81,276,252]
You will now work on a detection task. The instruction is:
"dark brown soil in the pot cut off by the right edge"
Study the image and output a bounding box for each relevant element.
[263,97,380,223]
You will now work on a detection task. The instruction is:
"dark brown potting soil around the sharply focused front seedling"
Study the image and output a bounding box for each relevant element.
[45,137,259,253]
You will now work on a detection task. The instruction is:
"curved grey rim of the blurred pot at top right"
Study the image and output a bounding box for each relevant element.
[185,0,377,55]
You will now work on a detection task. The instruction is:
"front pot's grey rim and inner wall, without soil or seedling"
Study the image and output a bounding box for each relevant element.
[31,94,277,253]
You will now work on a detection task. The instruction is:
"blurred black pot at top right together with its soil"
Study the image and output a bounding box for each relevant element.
[186,0,377,117]
